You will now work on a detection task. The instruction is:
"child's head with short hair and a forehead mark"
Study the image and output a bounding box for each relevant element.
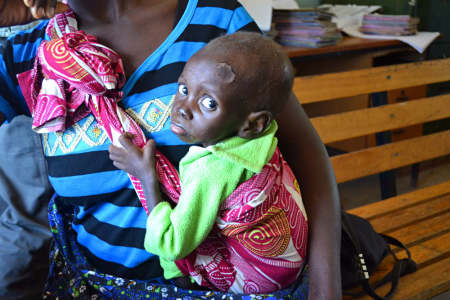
[171,32,294,146]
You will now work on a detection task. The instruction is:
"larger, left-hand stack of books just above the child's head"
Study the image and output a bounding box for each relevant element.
[272,9,342,48]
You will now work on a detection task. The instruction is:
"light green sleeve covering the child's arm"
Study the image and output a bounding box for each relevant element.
[144,151,253,261]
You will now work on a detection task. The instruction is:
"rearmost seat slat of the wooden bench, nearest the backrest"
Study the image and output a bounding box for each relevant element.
[348,180,450,220]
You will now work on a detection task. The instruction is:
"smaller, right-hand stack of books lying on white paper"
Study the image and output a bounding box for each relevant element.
[359,14,419,36]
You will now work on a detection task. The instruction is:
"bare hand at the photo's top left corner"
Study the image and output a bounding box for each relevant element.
[0,0,67,26]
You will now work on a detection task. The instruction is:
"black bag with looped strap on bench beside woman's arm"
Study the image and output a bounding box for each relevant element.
[342,212,417,300]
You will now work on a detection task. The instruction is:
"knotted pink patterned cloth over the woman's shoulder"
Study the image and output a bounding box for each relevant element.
[17,10,177,213]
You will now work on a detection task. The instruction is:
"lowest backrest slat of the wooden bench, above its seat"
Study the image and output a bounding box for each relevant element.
[331,130,450,183]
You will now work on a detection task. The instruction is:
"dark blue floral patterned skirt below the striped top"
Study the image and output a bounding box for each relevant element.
[43,199,309,300]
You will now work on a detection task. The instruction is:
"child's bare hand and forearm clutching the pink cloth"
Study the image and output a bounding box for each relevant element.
[109,133,163,212]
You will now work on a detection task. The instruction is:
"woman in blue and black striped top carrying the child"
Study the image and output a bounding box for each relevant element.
[0,0,340,299]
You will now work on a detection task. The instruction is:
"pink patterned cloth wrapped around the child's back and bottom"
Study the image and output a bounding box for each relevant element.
[163,148,308,294]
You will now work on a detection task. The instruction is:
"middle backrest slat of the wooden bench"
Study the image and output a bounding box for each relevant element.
[311,94,450,144]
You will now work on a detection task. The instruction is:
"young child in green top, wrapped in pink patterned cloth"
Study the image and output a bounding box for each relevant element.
[109,33,308,293]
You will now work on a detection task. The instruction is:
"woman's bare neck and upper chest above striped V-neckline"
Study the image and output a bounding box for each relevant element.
[69,0,178,75]
